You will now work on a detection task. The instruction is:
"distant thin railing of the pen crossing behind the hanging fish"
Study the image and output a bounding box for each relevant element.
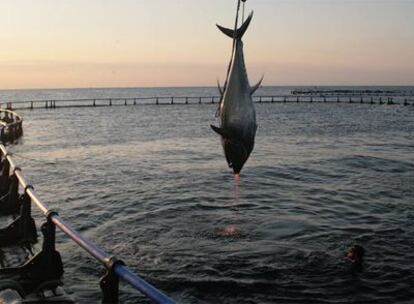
[0,94,414,110]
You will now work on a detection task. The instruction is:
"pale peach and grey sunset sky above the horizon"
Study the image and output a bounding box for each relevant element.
[0,0,414,89]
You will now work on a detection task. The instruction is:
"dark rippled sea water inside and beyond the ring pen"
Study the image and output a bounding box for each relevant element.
[0,87,414,304]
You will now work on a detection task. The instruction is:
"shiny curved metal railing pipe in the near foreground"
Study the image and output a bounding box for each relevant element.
[0,144,175,304]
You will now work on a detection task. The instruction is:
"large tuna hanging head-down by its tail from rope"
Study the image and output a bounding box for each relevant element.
[211,0,263,174]
